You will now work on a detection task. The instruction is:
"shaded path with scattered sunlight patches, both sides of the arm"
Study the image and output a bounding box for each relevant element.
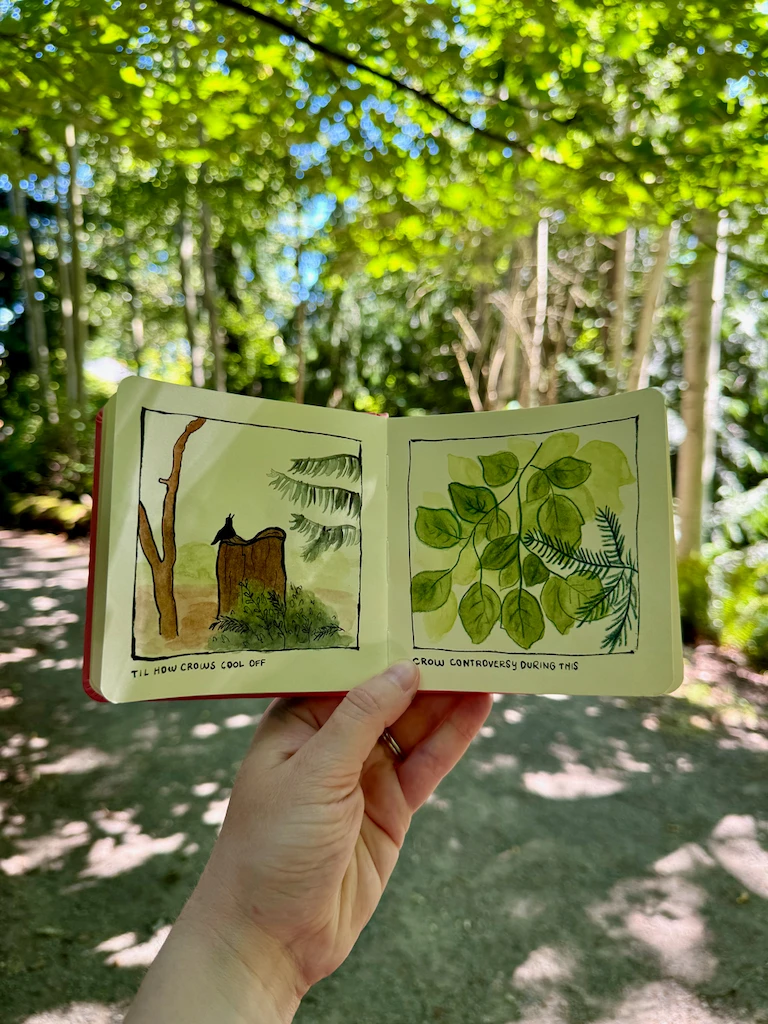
[0,534,768,1024]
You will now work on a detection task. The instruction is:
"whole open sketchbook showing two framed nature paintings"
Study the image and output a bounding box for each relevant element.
[84,378,683,702]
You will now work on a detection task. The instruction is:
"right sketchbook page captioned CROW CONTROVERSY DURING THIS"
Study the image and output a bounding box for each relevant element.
[388,391,677,695]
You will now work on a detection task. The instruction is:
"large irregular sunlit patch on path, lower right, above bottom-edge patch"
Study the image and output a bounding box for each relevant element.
[588,874,717,984]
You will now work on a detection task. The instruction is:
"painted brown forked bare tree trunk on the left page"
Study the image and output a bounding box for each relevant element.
[138,417,206,640]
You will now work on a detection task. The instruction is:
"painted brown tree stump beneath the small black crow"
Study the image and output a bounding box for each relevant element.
[216,526,286,616]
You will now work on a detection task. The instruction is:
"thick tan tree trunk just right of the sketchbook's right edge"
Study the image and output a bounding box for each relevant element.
[676,224,715,558]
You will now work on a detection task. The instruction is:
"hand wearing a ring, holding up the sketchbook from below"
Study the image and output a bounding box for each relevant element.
[129,663,492,1024]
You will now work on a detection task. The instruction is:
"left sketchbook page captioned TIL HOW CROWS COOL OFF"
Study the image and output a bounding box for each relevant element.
[94,378,386,702]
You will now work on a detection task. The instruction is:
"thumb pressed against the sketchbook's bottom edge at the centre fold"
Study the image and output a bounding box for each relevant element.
[305,662,419,779]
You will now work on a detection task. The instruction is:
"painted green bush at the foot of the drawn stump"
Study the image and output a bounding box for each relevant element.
[210,584,353,651]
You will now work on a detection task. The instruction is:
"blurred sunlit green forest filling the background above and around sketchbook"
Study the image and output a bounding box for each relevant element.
[0,0,768,665]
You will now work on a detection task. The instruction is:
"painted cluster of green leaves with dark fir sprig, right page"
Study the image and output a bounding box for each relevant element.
[411,431,639,653]
